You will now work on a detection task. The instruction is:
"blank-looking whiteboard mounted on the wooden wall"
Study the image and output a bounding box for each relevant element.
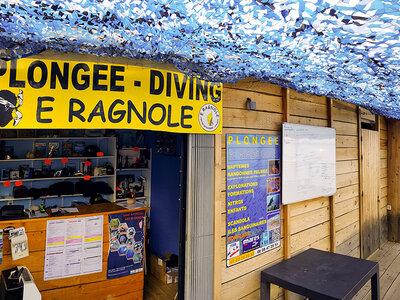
[282,123,336,204]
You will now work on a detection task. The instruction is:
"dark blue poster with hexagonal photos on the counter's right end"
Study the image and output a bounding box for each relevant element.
[107,211,145,279]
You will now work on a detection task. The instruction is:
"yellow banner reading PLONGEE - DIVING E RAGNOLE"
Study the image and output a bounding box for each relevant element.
[0,59,222,134]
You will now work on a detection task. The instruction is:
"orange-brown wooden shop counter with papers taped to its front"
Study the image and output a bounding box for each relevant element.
[0,203,149,300]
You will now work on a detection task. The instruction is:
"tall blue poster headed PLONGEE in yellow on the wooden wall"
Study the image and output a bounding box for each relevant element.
[226,134,281,267]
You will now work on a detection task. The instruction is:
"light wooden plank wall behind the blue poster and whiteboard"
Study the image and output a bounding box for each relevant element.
[214,79,387,300]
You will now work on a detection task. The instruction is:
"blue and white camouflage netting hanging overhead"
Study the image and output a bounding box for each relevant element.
[0,0,400,118]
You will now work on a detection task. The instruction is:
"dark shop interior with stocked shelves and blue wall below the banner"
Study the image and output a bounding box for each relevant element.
[0,129,186,299]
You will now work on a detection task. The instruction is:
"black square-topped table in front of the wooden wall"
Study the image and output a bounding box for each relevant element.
[261,248,379,300]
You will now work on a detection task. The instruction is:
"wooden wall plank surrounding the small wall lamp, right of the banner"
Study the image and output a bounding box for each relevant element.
[223,88,283,113]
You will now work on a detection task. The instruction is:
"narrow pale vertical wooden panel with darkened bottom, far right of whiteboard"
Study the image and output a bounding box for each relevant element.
[361,129,380,257]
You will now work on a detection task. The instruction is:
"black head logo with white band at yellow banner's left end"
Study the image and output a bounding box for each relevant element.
[0,90,23,127]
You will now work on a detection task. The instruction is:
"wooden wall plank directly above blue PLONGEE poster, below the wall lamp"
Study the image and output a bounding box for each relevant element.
[224,108,282,130]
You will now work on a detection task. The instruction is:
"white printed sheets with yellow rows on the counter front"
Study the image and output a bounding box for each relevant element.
[44,215,103,280]
